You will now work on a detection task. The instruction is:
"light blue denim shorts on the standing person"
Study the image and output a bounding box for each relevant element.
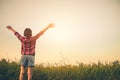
[20,55,35,67]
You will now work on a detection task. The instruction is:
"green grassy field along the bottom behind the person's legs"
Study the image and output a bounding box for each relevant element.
[0,59,120,80]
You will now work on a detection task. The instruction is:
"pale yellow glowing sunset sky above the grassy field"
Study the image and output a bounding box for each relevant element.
[0,0,120,64]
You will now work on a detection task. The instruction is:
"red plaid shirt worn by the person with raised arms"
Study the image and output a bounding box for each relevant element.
[15,32,37,55]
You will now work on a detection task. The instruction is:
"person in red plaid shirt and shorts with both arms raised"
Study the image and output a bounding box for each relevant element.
[7,23,54,80]
